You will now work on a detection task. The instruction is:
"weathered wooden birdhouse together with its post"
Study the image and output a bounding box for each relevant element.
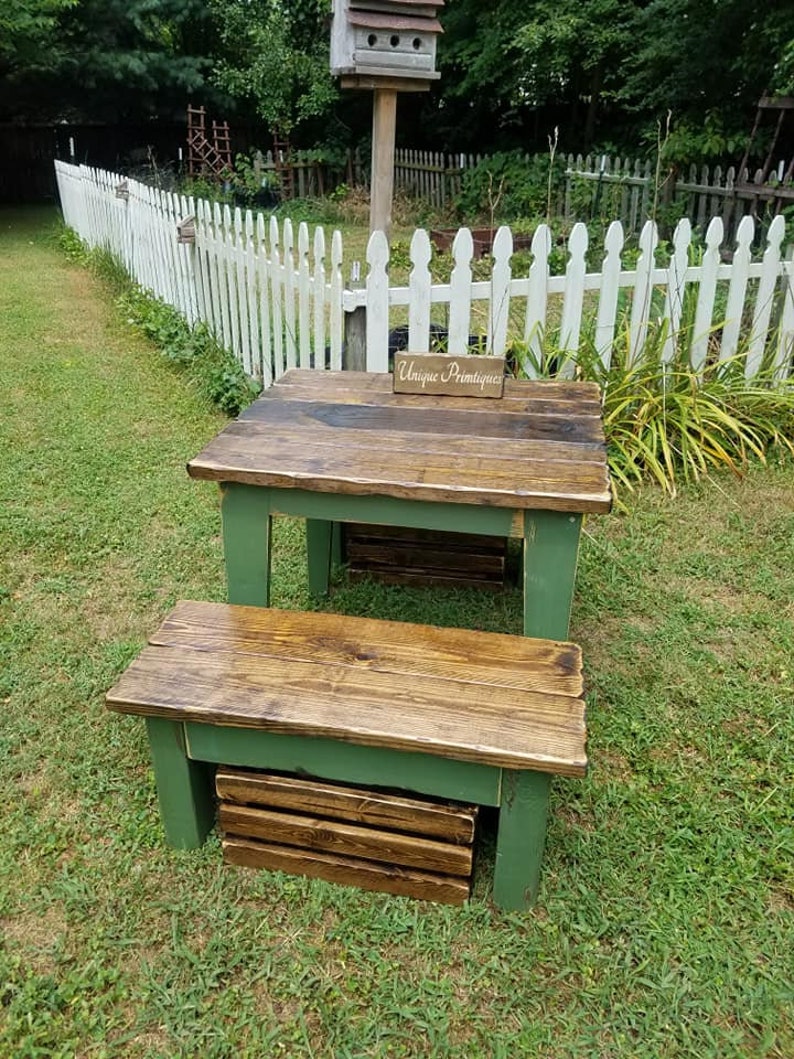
[330,0,444,236]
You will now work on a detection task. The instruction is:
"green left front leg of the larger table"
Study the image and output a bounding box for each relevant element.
[220,482,271,607]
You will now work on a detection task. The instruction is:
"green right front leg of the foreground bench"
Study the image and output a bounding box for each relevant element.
[493,769,551,911]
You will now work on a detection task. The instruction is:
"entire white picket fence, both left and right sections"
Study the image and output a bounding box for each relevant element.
[56,162,794,385]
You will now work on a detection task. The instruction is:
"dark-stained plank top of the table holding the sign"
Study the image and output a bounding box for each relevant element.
[187,369,611,513]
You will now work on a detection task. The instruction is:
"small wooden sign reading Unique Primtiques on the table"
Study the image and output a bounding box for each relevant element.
[394,353,505,397]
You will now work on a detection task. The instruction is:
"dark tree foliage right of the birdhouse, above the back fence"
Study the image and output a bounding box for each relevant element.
[431,0,794,155]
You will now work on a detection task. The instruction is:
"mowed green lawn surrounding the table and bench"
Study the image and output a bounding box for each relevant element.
[0,212,794,1059]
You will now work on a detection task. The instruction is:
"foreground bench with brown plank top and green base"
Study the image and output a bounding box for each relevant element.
[107,602,587,909]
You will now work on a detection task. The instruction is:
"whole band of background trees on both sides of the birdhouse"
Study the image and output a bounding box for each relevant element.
[0,0,794,161]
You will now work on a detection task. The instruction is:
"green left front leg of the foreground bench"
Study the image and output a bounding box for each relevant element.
[146,717,215,849]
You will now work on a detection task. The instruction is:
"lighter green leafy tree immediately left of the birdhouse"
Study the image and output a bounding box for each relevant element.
[212,0,337,136]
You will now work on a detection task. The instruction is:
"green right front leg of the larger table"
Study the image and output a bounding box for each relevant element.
[524,511,581,640]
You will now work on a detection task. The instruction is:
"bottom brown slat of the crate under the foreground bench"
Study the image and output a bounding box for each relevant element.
[223,839,470,904]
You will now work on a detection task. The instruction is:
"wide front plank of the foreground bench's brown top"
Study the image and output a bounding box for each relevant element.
[107,647,587,775]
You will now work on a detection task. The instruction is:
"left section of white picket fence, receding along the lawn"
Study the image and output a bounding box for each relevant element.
[55,162,343,385]
